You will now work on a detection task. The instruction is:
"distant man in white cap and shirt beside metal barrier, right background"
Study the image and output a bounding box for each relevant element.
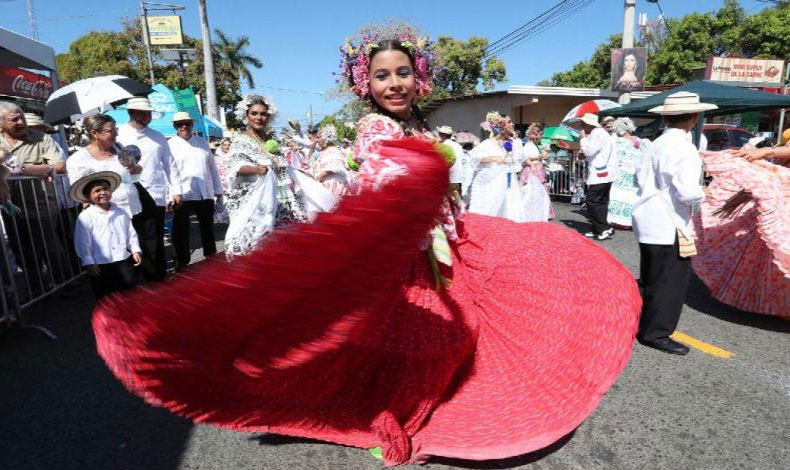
[580,113,614,240]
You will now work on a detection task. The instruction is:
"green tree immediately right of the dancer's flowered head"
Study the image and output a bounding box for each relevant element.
[428,36,507,101]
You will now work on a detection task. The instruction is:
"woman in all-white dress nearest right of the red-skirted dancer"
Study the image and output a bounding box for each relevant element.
[469,112,526,222]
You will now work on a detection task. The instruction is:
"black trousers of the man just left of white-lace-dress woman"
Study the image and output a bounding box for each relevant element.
[173,199,217,269]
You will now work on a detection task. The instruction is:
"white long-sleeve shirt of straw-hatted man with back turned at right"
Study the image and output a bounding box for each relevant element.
[633,128,705,245]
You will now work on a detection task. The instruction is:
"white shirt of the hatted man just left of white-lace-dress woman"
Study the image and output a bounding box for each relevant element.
[168,136,222,201]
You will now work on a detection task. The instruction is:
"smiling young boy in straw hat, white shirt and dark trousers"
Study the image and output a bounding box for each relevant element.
[69,171,142,300]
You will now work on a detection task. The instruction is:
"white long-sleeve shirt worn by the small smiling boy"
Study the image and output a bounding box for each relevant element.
[74,204,141,266]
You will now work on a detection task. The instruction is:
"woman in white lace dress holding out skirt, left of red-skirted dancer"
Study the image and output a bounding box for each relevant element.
[224,95,337,258]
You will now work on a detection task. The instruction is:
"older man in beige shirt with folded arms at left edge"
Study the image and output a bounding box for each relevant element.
[0,102,68,297]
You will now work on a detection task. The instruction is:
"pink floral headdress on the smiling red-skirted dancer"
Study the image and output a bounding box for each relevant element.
[338,26,436,99]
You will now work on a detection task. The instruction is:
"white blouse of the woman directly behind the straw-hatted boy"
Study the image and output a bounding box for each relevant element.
[66,147,143,217]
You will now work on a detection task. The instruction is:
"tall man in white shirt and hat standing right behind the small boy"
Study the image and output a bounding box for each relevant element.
[117,98,181,281]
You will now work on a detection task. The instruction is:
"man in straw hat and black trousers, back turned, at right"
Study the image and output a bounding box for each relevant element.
[633,92,716,354]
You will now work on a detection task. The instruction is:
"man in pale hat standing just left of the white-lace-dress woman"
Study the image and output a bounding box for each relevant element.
[168,112,222,271]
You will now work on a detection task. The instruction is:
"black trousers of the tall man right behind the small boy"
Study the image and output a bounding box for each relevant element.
[132,183,167,281]
